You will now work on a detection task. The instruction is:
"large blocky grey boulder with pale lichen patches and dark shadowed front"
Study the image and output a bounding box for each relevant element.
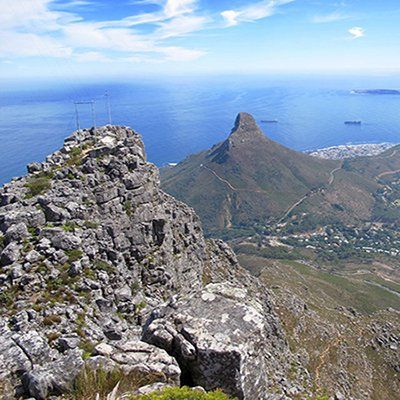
[143,284,286,399]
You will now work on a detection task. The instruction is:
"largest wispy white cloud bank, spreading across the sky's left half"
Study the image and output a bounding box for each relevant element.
[0,0,207,62]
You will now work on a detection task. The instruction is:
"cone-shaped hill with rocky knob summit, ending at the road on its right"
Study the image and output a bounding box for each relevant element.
[162,113,339,234]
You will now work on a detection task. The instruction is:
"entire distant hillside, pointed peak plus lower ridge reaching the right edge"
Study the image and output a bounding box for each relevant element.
[162,113,400,234]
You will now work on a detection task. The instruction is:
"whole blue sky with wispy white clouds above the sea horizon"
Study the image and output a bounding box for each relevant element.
[0,0,400,80]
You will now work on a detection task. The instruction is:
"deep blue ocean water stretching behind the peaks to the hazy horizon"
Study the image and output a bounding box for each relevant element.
[0,77,400,184]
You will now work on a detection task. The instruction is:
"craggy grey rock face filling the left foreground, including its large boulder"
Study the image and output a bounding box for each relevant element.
[0,126,300,399]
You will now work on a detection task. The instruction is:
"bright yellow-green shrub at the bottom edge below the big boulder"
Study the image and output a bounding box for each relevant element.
[130,387,233,400]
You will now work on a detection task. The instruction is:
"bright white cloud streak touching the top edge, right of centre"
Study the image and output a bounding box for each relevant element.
[221,0,294,27]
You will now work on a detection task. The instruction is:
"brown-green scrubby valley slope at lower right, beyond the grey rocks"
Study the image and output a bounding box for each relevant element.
[239,254,400,400]
